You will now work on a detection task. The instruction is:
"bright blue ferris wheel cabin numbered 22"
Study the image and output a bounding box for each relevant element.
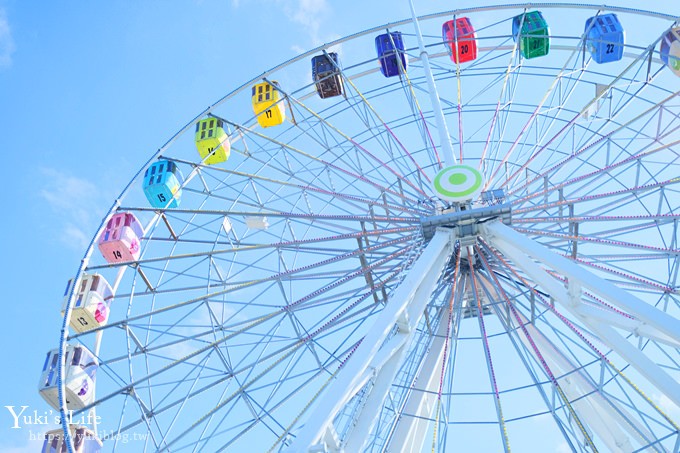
[585,14,626,63]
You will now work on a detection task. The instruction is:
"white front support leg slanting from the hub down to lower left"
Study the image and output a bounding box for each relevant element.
[289,229,456,452]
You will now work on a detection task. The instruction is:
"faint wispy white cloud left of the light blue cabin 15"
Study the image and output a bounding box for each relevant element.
[39,168,110,251]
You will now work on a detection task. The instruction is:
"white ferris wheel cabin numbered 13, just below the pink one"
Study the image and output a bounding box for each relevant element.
[61,274,113,333]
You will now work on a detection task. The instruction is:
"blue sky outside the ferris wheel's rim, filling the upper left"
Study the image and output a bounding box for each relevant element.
[0,0,680,451]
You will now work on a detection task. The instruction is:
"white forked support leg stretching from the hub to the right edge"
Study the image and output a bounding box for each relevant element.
[480,221,680,406]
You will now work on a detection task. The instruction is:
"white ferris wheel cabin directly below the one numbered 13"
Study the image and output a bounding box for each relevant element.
[38,344,99,410]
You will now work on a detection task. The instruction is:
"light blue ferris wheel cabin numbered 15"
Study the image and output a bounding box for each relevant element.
[144,159,184,209]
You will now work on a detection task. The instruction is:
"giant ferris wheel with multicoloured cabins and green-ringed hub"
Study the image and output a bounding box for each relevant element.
[39,4,680,452]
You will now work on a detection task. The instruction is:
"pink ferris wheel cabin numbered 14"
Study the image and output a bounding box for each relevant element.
[99,212,144,263]
